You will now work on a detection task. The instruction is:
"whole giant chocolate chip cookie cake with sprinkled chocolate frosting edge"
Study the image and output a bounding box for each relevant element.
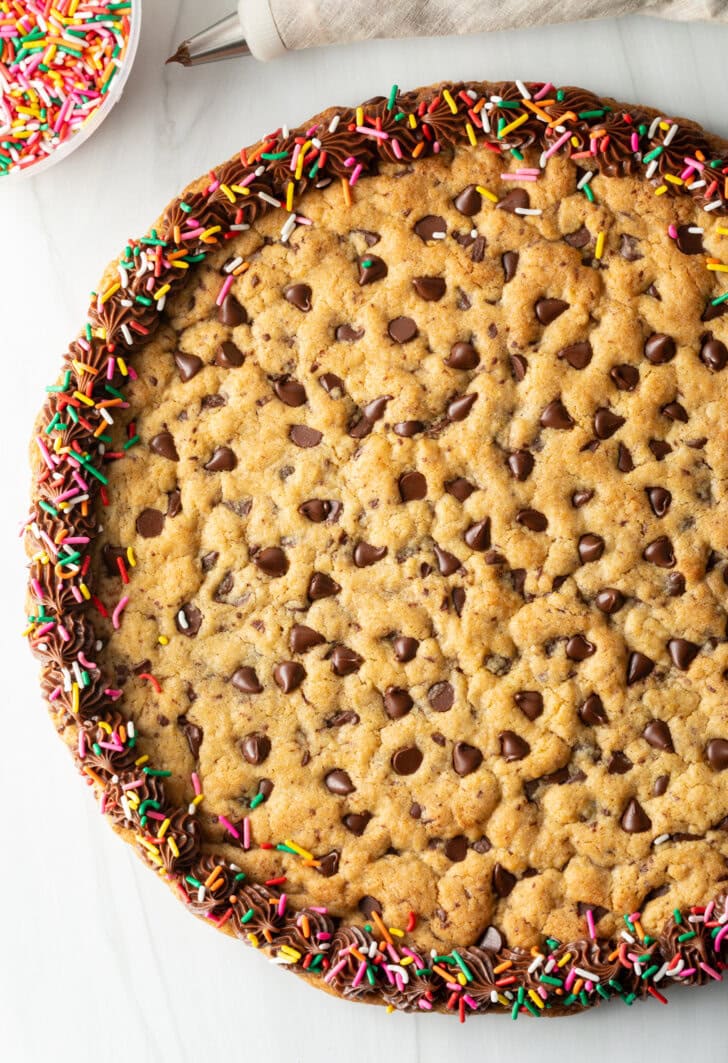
[26,82,728,1020]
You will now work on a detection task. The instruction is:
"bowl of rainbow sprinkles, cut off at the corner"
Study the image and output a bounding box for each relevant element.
[0,0,141,179]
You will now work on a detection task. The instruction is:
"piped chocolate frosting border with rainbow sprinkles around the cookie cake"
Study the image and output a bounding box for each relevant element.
[26,82,728,1020]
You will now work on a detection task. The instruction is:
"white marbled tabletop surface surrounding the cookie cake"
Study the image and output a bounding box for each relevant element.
[0,0,728,1063]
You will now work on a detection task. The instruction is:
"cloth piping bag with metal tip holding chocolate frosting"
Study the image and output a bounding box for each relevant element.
[167,0,728,66]
